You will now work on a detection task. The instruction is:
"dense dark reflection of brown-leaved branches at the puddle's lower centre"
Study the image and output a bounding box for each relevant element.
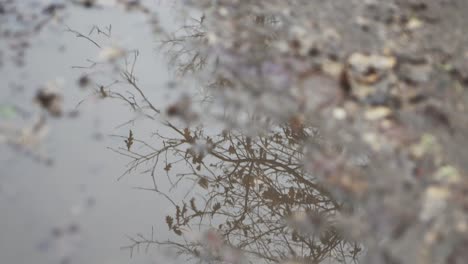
[117,123,361,263]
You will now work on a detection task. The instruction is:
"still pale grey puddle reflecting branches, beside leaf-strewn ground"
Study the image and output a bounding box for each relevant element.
[0,4,356,264]
